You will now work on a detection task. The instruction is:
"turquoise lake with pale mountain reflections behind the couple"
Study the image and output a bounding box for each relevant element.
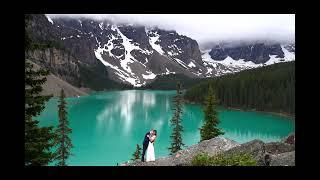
[35,90,295,166]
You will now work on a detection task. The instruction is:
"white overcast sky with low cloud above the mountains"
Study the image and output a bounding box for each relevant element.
[47,14,295,46]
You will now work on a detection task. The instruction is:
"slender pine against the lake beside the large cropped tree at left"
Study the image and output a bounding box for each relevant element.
[56,89,73,166]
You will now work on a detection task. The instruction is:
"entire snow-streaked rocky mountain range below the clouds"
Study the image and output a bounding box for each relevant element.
[27,15,295,87]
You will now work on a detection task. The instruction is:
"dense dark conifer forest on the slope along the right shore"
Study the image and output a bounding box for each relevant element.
[185,61,295,115]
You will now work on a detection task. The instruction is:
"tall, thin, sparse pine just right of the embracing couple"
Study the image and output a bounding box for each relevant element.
[168,82,184,155]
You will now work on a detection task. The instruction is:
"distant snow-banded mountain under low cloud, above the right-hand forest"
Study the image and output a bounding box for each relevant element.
[202,43,295,77]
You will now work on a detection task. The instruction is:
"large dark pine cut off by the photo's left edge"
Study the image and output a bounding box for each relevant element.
[25,60,55,166]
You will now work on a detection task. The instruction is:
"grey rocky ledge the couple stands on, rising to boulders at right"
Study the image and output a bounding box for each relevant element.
[122,133,295,166]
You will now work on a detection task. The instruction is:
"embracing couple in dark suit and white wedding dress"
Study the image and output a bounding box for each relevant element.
[141,129,157,162]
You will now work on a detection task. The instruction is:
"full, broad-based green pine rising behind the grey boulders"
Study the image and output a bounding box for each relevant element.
[200,86,224,141]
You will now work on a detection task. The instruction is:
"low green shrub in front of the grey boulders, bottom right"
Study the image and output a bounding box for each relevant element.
[191,153,258,166]
